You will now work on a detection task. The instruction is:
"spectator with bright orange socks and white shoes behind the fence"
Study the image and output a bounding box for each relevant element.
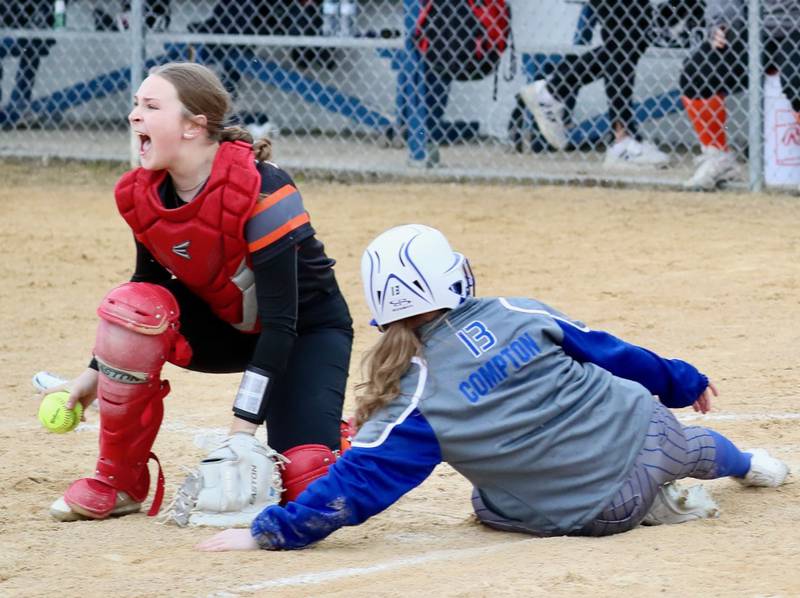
[680,0,800,189]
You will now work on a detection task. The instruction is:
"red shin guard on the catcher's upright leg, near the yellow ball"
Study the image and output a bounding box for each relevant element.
[64,283,191,519]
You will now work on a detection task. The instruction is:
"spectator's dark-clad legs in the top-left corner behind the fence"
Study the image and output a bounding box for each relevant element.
[0,0,55,129]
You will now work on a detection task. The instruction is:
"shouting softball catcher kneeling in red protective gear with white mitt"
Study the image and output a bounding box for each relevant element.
[50,63,352,526]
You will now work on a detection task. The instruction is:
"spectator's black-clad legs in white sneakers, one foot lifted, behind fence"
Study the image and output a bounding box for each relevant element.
[520,0,696,167]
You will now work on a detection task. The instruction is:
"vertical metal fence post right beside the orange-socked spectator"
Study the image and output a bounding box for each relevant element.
[747,0,764,192]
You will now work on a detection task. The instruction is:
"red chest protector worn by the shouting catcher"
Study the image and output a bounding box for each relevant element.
[114,141,261,332]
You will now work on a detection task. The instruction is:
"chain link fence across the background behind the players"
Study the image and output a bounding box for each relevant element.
[0,0,800,189]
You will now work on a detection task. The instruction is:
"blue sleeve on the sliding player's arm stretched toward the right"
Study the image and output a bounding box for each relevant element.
[556,319,708,407]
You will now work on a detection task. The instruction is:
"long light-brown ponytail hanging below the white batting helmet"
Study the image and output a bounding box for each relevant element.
[355,319,422,428]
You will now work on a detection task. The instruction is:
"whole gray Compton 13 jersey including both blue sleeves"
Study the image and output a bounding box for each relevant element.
[251,298,713,548]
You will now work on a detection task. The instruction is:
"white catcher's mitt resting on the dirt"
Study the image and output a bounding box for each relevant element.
[162,432,284,527]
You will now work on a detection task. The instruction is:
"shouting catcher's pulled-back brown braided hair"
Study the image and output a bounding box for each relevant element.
[150,62,272,162]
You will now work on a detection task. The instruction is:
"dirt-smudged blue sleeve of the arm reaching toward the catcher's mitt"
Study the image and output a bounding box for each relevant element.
[250,409,442,550]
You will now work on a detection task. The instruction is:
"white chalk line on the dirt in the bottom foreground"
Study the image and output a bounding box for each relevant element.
[209,538,530,598]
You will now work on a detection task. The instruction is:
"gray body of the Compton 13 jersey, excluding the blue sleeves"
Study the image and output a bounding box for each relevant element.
[357,299,654,533]
